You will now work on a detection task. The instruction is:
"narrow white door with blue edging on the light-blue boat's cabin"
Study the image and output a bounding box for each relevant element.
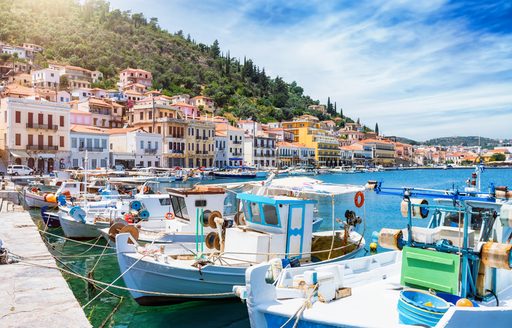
[286,205,304,259]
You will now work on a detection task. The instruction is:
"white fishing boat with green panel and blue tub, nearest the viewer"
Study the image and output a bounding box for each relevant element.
[235,189,512,328]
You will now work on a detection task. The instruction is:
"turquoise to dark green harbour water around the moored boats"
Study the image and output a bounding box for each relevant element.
[34,169,512,327]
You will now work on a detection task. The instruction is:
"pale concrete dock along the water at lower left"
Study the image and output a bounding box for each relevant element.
[0,200,91,327]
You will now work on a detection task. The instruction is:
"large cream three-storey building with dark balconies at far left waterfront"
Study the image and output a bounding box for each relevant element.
[0,97,70,172]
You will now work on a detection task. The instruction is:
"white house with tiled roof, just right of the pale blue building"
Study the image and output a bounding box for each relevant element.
[109,128,162,168]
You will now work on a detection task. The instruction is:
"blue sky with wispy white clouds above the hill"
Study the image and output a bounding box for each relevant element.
[110,0,512,140]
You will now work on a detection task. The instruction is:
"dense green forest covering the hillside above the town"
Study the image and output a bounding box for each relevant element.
[0,0,341,122]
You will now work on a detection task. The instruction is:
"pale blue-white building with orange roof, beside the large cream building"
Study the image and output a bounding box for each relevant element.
[70,125,110,170]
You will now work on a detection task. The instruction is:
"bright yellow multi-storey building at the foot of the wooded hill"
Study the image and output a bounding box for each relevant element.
[282,115,340,166]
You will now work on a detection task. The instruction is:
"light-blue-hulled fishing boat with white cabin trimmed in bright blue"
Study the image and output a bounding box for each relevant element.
[116,179,365,305]
